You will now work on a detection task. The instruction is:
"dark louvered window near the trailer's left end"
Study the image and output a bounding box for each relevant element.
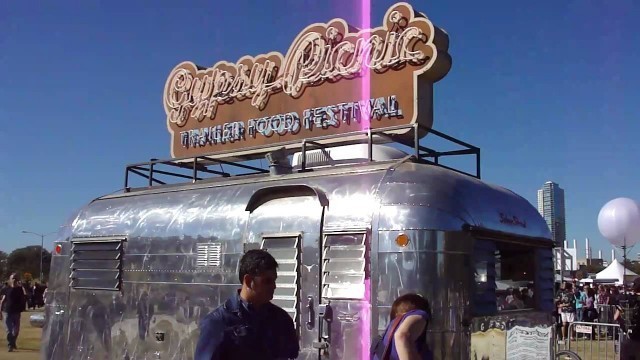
[69,237,126,291]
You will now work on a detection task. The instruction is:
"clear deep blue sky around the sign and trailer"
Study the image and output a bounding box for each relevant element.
[0,0,640,257]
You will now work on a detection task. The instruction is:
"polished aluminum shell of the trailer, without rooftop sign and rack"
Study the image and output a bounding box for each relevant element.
[42,157,553,359]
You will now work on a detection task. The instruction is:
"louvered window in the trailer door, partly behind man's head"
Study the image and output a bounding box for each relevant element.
[261,236,300,326]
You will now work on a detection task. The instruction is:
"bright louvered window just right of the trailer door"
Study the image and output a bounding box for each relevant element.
[322,233,368,300]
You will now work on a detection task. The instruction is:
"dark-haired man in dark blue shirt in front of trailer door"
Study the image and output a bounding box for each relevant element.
[194,250,300,360]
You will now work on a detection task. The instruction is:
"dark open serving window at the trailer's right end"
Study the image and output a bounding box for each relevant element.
[475,241,537,315]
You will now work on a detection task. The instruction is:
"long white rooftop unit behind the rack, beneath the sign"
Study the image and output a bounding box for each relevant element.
[293,144,407,168]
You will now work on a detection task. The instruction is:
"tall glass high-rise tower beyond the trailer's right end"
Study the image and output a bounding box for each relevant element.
[538,181,567,246]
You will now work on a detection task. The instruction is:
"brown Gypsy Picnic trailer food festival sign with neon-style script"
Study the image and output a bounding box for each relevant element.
[163,3,451,157]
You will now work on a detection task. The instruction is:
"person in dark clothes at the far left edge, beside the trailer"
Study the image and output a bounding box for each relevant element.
[0,273,27,352]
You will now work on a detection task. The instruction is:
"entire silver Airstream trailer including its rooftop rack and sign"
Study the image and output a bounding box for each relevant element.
[42,3,554,360]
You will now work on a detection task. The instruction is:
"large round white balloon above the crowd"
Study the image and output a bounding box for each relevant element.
[598,198,640,246]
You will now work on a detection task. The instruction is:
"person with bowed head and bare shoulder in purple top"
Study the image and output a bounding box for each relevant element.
[371,294,433,360]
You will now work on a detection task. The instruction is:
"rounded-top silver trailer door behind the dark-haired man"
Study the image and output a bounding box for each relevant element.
[244,186,326,359]
